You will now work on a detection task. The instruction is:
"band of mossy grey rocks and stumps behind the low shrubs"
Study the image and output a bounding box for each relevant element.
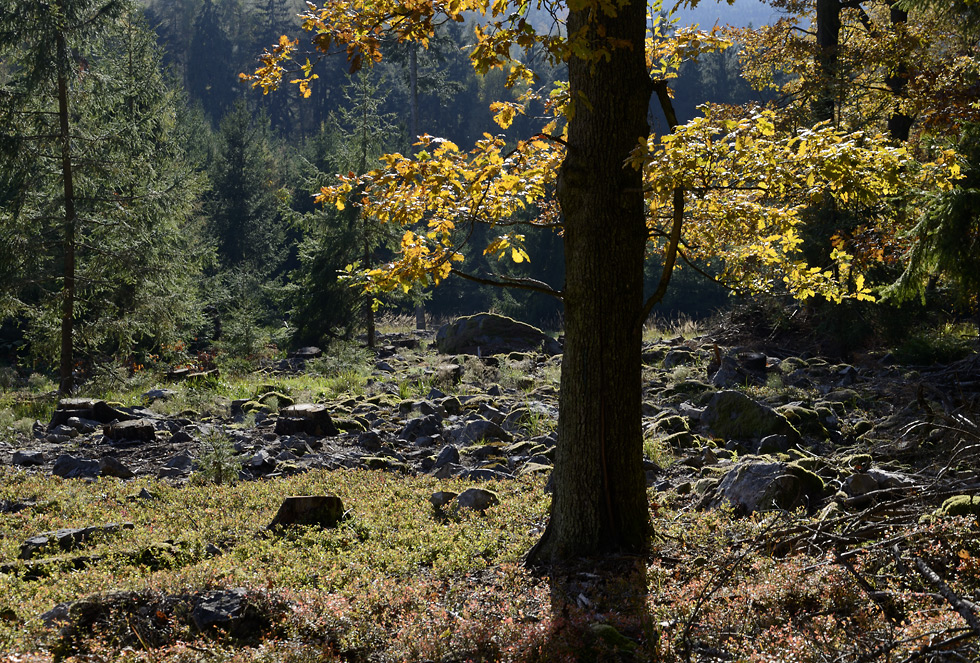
[0,317,980,524]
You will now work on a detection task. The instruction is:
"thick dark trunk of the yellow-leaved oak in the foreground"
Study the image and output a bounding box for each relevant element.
[528,0,652,563]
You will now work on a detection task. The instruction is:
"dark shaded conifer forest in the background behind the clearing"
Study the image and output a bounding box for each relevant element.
[0,0,792,370]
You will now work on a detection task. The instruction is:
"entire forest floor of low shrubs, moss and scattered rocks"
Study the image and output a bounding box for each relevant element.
[0,308,980,663]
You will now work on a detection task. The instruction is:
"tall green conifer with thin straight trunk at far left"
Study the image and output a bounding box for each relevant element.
[0,0,203,393]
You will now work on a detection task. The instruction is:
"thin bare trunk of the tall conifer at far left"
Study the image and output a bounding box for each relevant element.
[57,33,75,394]
